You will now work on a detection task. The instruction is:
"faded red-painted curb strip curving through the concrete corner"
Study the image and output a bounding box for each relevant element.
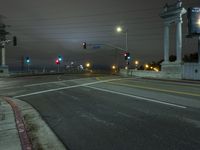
[3,97,32,150]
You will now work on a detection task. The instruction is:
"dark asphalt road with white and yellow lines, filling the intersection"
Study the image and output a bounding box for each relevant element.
[0,75,200,150]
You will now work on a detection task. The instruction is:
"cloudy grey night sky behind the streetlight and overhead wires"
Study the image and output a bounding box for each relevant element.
[0,0,200,68]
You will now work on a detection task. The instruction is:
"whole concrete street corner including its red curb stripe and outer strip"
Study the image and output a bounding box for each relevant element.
[0,97,66,150]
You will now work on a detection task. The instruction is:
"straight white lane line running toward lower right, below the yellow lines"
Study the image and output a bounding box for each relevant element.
[85,85,187,109]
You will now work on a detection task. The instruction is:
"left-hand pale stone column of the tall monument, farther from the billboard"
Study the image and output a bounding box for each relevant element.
[164,24,169,63]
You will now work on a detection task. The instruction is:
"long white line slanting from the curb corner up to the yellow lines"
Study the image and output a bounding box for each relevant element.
[13,79,122,98]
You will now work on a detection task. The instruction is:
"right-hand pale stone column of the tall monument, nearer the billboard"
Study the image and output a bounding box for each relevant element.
[176,20,182,63]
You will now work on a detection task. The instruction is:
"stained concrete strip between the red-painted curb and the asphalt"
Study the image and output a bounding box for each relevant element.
[4,98,67,150]
